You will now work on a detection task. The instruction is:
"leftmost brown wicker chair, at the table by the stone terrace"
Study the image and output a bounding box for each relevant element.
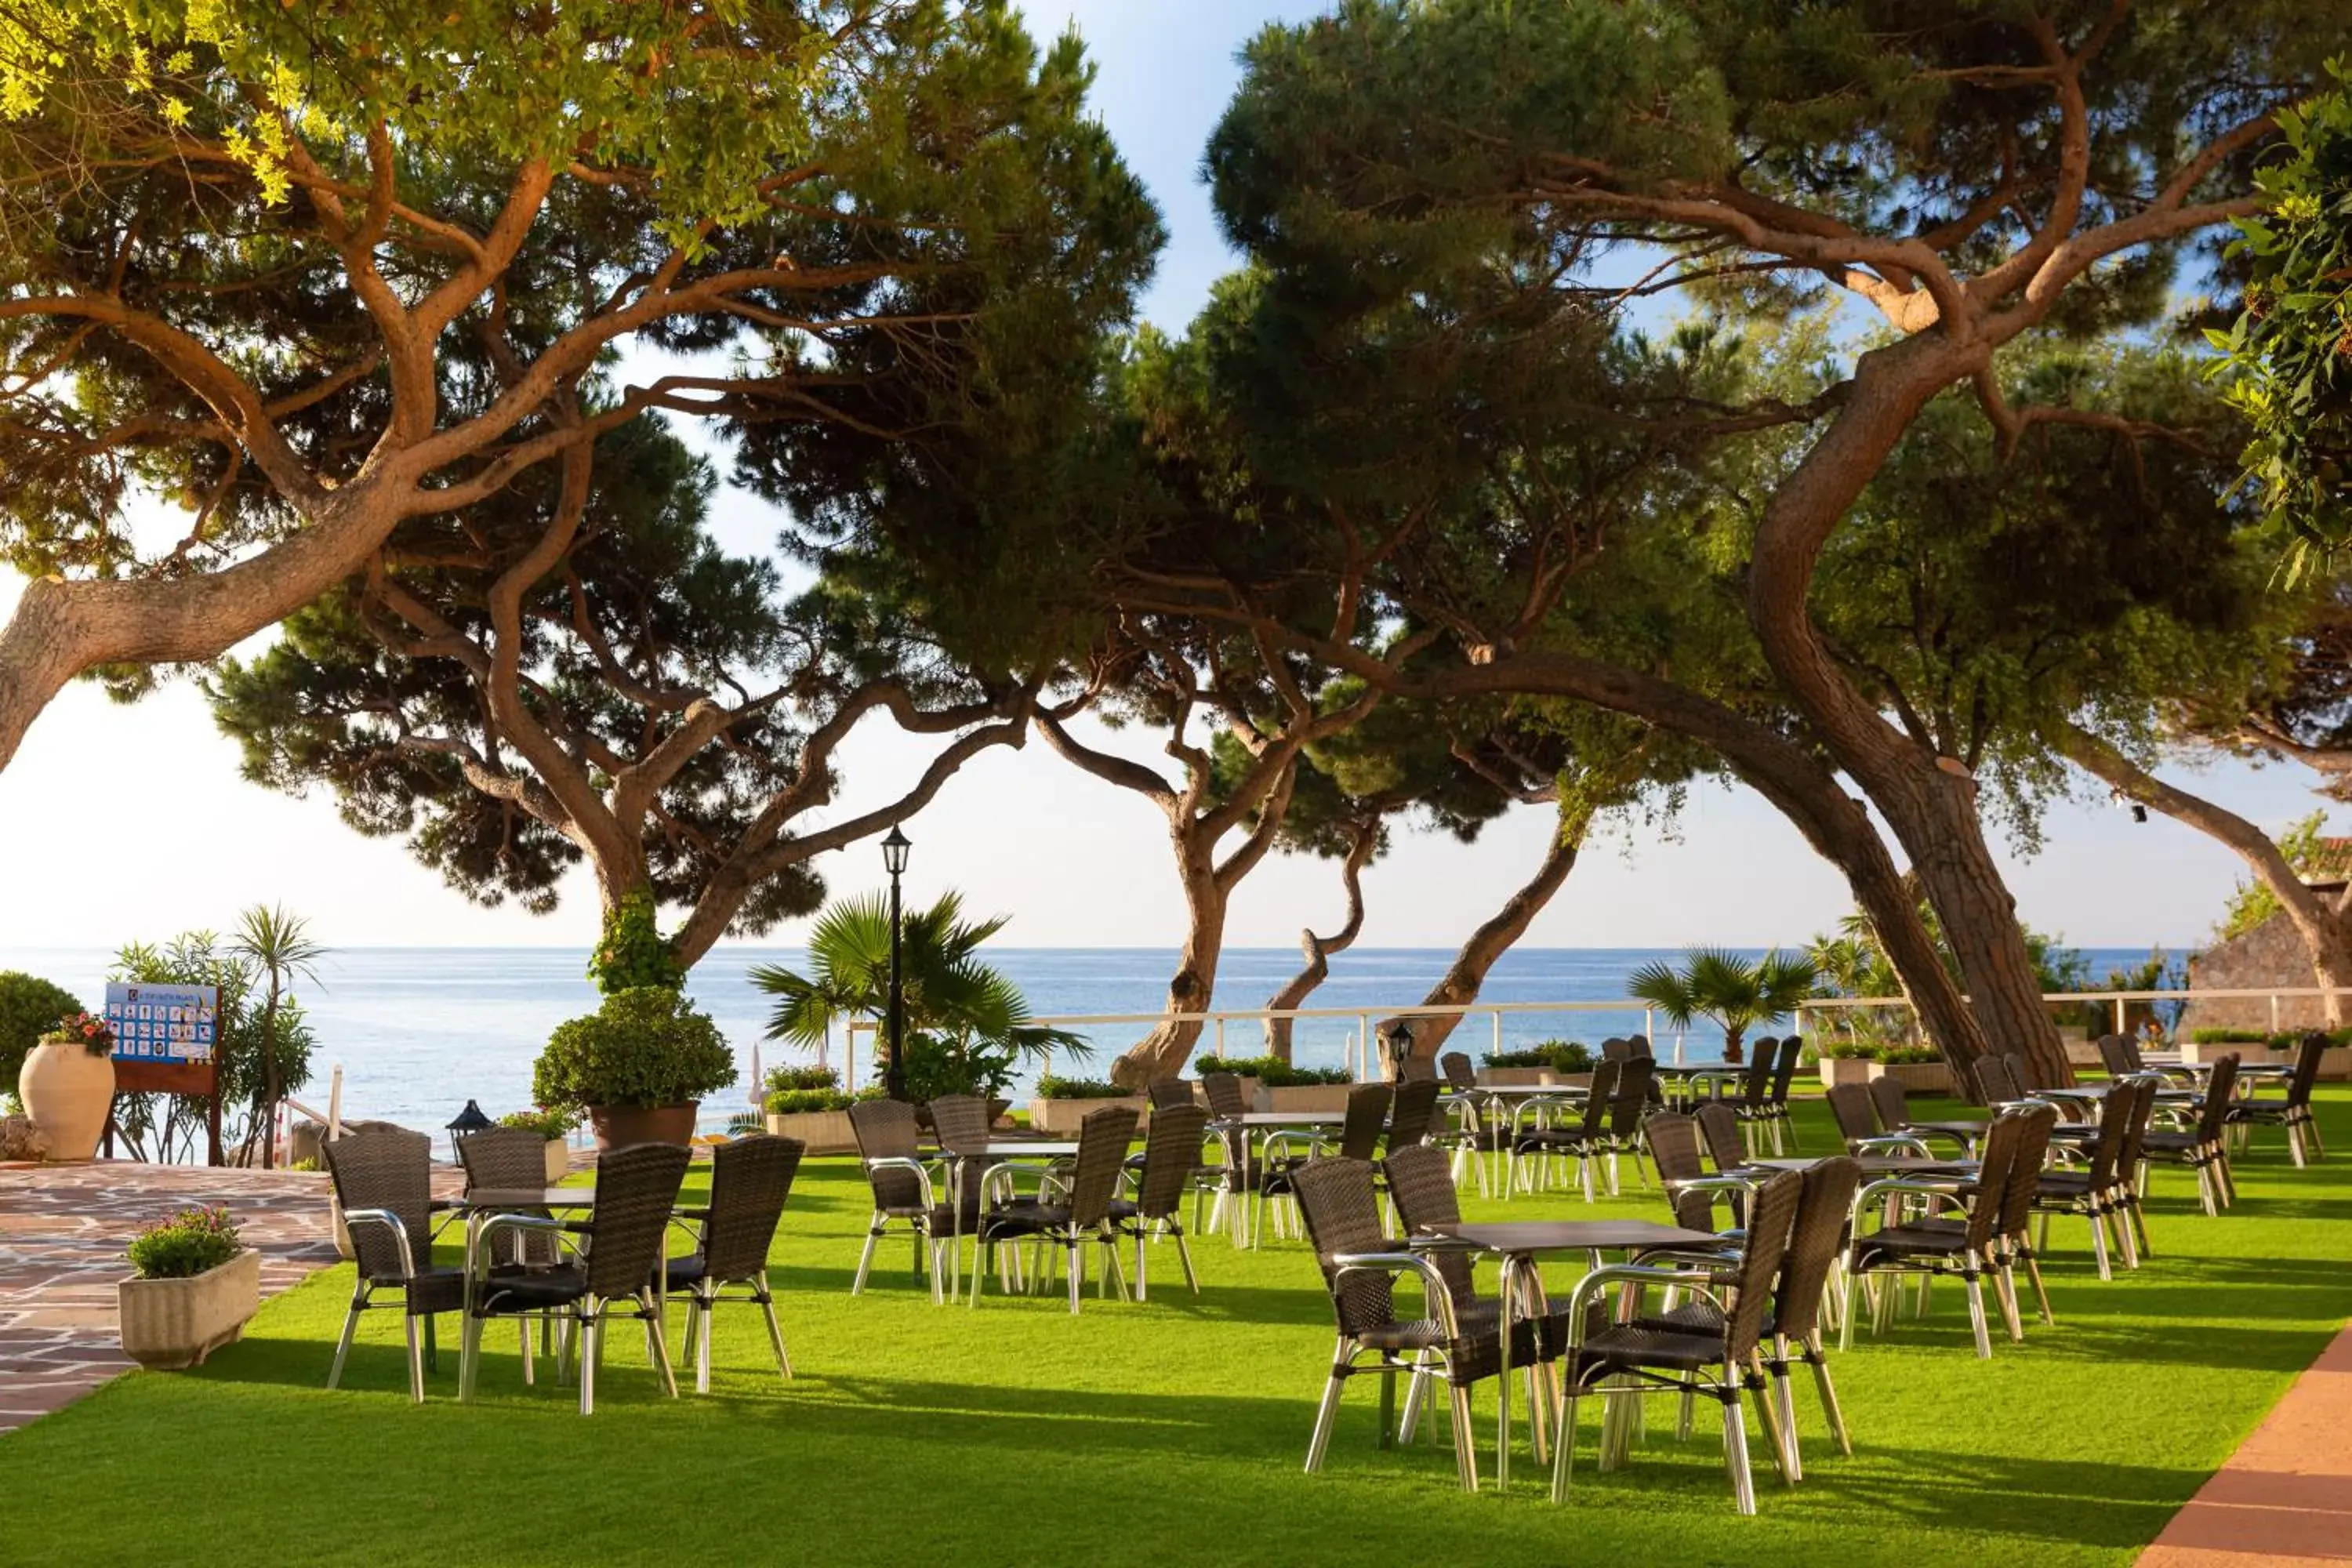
[320,1128,466,1403]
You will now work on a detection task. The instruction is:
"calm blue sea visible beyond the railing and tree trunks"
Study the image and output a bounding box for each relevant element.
[0,942,2147,1131]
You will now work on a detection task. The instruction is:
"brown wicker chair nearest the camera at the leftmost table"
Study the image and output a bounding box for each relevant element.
[459,1142,687,1415]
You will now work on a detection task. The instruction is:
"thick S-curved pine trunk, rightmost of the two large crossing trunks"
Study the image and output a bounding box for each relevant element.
[1748,332,2074,1086]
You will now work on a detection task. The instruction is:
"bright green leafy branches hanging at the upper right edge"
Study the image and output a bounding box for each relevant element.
[2206,61,2352,572]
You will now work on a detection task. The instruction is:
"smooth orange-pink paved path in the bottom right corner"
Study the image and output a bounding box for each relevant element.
[2138,1328,2352,1568]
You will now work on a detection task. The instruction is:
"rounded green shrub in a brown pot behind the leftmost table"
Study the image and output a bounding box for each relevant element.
[532,985,736,1149]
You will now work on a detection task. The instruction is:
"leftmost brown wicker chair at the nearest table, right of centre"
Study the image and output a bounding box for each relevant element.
[1296,1149,1536,1493]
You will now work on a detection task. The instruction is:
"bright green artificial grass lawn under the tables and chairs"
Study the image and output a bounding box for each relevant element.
[0,1086,2352,1568]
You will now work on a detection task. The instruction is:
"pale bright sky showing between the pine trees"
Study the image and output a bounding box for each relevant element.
[0,0,2343,968]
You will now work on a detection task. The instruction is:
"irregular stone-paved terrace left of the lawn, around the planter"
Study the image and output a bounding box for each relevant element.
[0,1161,353,1432]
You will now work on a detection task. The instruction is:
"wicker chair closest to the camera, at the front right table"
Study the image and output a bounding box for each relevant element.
[1548,1171,1804,1514]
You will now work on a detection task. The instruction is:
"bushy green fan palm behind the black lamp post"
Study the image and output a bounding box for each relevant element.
[750,891,1091,1093]
